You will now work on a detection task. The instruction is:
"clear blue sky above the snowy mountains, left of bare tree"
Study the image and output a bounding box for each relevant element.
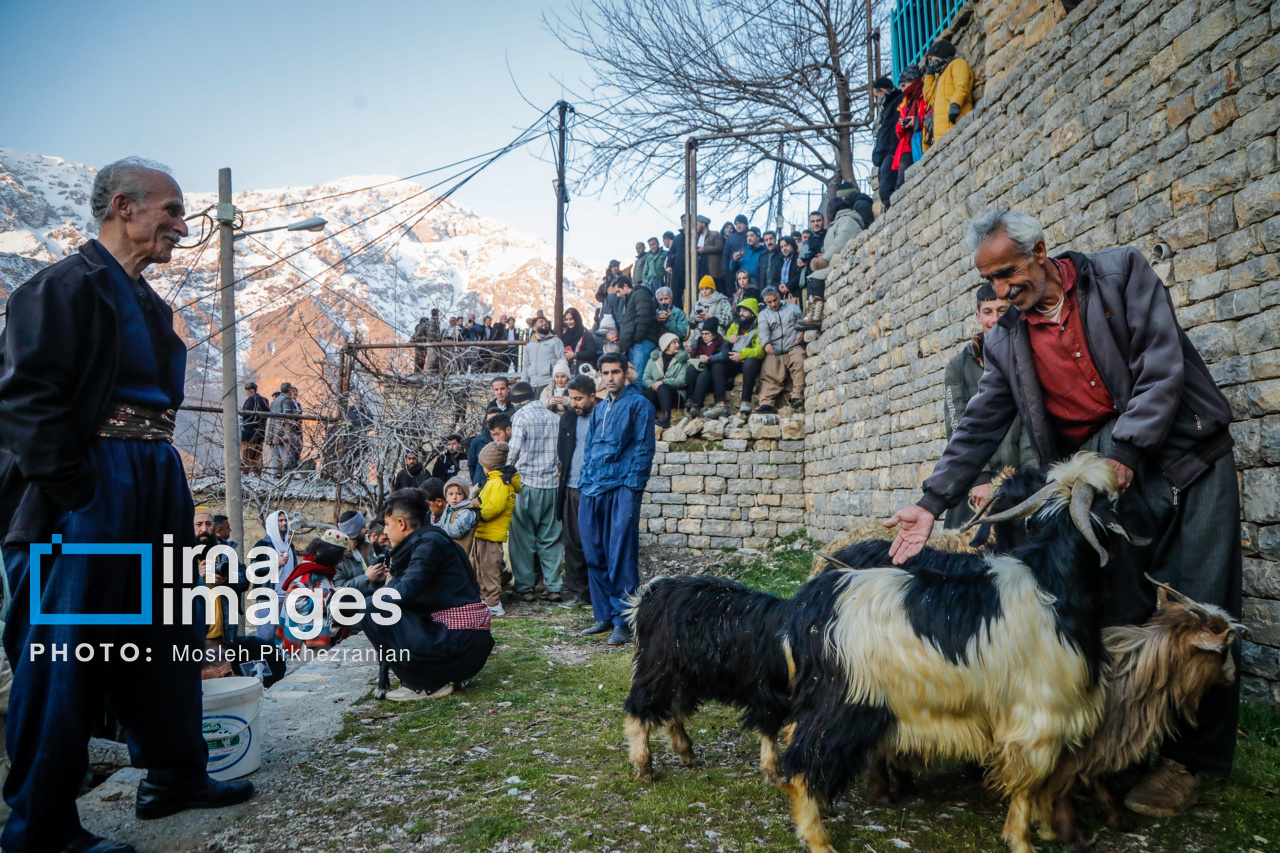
[0,0,824,264]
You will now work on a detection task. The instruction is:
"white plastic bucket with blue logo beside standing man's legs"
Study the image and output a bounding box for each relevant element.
[201,676,264,781]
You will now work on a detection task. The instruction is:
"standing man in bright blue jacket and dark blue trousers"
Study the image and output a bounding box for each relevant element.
[577,352,654,646]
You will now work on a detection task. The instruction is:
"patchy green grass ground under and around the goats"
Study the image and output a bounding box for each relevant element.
[317,545,1280,853]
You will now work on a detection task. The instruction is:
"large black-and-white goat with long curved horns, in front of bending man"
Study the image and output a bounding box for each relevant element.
[781,452,1125,853]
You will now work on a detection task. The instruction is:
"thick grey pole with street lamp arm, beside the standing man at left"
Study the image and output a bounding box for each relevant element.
[218,169,244,557]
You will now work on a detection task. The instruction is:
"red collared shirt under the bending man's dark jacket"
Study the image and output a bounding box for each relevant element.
[1023,257,1116,447]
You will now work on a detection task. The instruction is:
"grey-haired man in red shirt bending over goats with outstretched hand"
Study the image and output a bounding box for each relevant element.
[886,210,1242,816]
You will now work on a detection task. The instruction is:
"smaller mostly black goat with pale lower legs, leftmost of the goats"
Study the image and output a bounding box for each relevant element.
[625,575,791,781]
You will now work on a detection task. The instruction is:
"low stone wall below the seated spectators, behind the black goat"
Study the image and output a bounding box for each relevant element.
[640,415,805,551]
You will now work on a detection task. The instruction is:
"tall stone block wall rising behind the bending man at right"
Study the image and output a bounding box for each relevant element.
[804,0,1280,701]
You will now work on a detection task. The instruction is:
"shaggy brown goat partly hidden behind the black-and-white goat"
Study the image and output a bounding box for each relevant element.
[1039,575,1239,850]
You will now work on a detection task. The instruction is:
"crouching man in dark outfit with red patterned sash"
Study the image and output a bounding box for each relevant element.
[361,488,493,702]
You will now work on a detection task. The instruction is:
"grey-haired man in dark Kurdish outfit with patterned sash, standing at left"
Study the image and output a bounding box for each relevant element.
[0,158,253,853]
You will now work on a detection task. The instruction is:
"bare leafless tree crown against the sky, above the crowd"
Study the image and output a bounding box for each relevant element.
[544,0,887,210]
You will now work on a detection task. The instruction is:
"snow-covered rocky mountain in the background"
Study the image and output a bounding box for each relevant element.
[0,147,603,402]
